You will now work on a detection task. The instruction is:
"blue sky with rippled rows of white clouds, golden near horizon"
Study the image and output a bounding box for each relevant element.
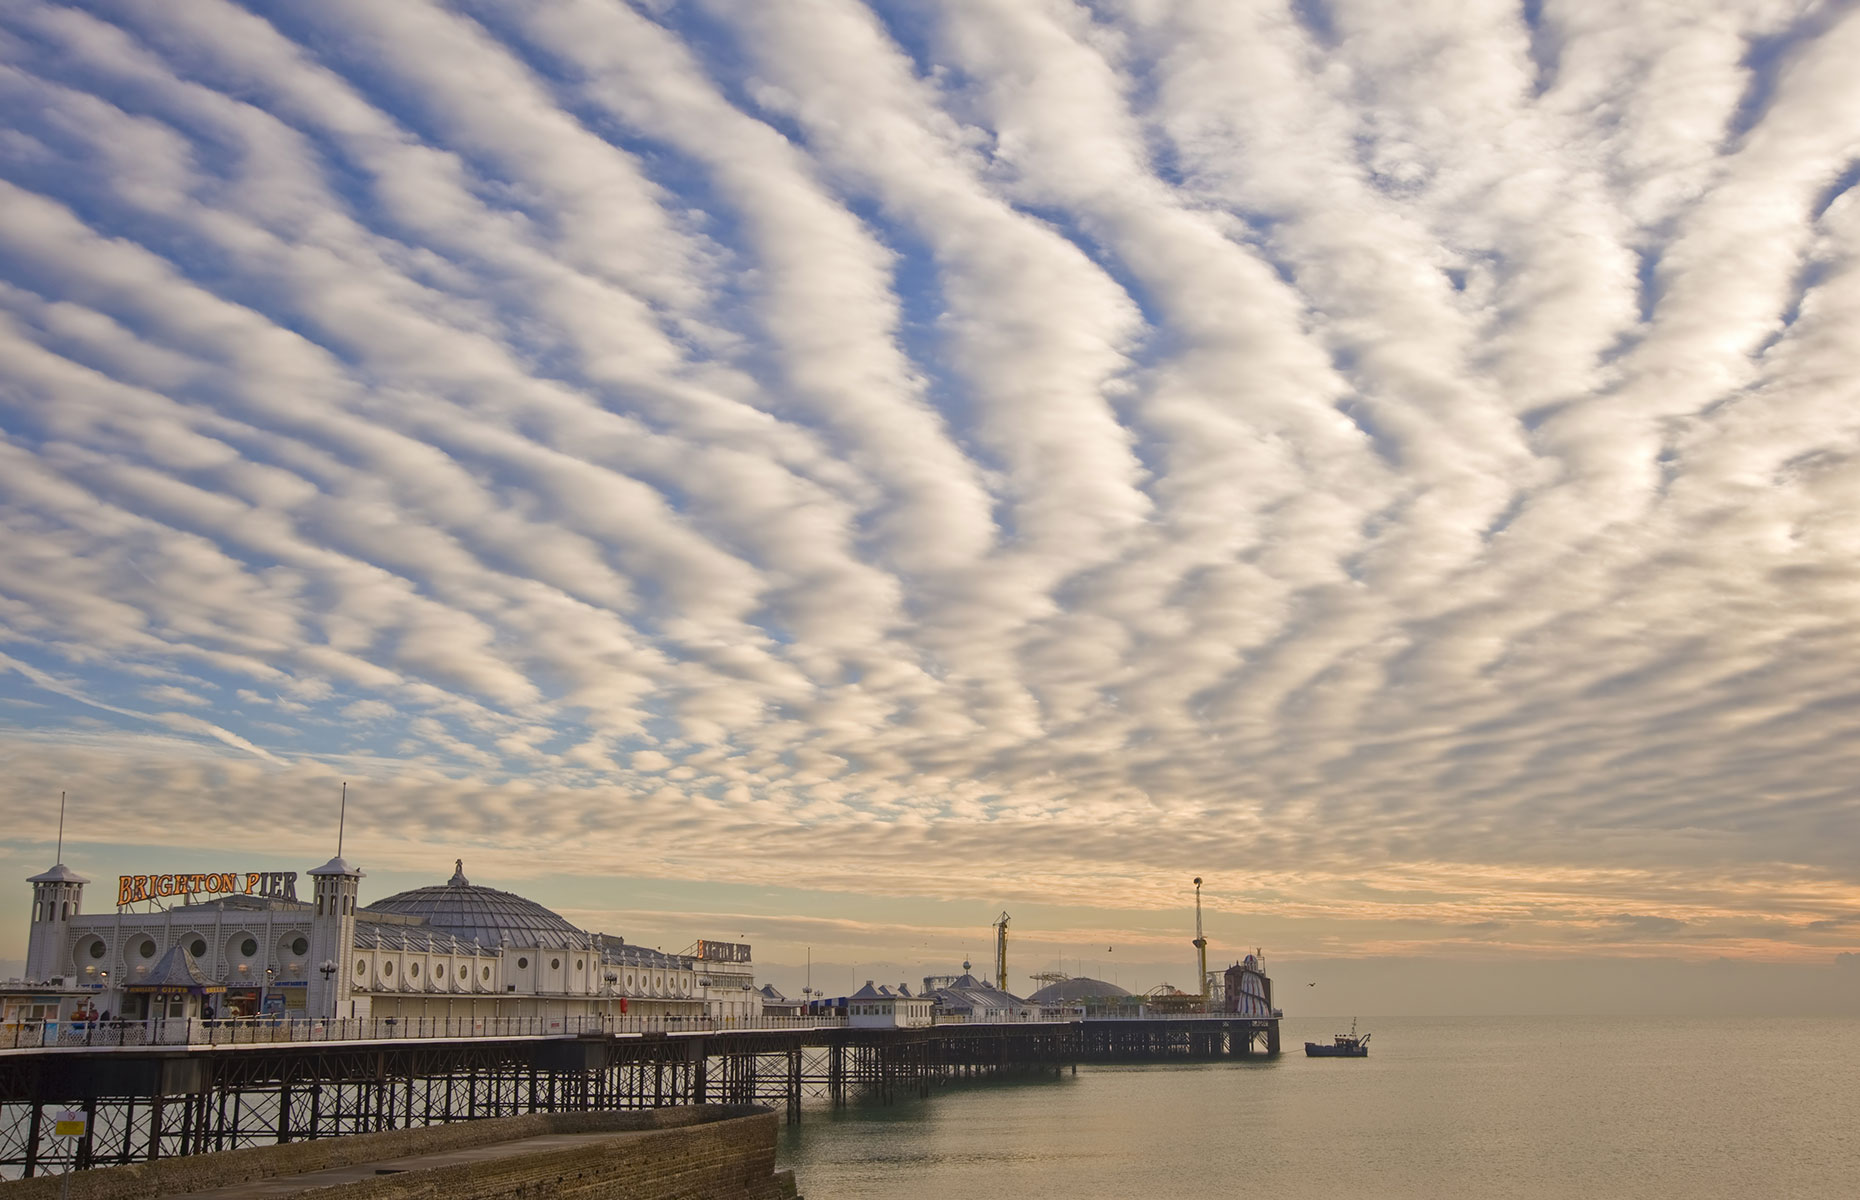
[0,0,1860,1008]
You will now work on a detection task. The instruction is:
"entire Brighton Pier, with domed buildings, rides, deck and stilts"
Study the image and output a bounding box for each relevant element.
[0,852,1280,1178]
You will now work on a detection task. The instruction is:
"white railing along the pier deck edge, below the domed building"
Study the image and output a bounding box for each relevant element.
[0,1014,846,1049]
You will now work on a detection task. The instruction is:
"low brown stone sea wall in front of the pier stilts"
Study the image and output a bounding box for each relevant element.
[0,1105,794,1200]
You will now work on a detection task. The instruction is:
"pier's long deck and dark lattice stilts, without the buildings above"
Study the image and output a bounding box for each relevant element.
[0,1014,1280,1178]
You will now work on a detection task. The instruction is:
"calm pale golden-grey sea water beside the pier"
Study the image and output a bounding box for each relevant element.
[783,1018,1860,1200]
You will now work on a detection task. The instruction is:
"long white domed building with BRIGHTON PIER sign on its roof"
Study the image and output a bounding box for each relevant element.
[0,856,763,1021]
